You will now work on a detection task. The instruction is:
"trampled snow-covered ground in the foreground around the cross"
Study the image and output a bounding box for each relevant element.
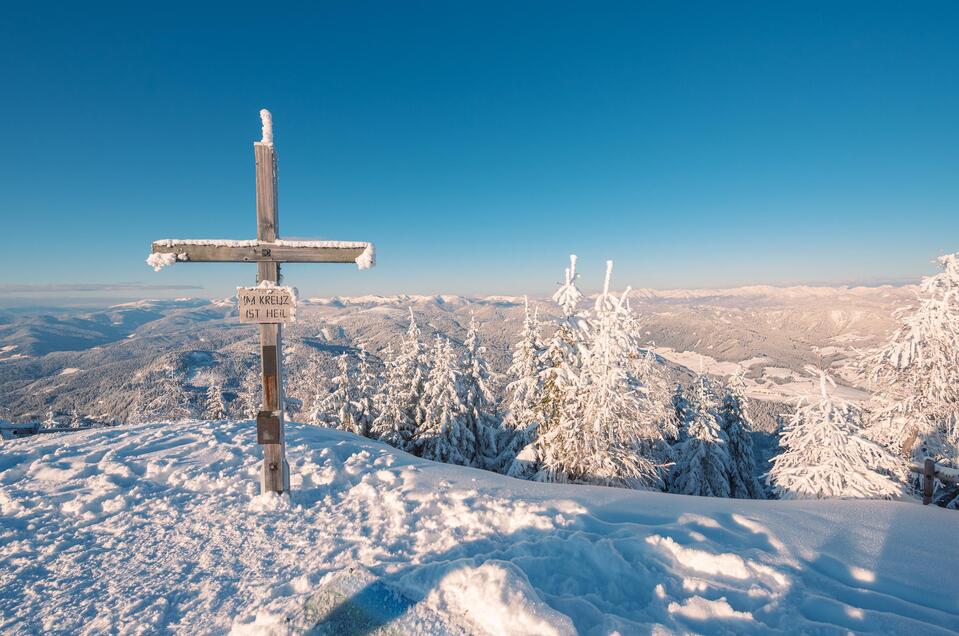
[0,421,959,635]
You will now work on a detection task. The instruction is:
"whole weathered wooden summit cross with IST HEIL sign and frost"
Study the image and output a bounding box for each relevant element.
[147,109,374,492]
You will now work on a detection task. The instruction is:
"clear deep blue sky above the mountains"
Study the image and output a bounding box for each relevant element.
[0,1,959,296]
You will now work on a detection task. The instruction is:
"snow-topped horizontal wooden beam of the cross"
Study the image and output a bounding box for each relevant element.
[152,239,373,269]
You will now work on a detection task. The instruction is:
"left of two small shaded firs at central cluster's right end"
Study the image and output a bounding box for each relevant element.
[669,373,732,497]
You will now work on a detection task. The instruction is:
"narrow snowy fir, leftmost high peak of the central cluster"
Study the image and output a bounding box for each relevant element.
[372,309,428,450]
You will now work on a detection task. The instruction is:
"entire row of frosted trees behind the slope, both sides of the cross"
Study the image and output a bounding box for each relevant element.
[131,254,959,508]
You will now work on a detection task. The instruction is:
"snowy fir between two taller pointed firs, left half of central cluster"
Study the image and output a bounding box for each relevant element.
[412,336,476,466]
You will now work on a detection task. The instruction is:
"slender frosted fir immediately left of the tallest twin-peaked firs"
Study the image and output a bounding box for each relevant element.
[494,299,545,476]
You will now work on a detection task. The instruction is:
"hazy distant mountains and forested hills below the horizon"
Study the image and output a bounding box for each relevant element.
[0,285,915,425]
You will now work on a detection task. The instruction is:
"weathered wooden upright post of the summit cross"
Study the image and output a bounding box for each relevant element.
[253,133,290,493]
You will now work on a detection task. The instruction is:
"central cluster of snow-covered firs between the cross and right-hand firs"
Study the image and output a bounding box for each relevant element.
[308,256,764,498]
